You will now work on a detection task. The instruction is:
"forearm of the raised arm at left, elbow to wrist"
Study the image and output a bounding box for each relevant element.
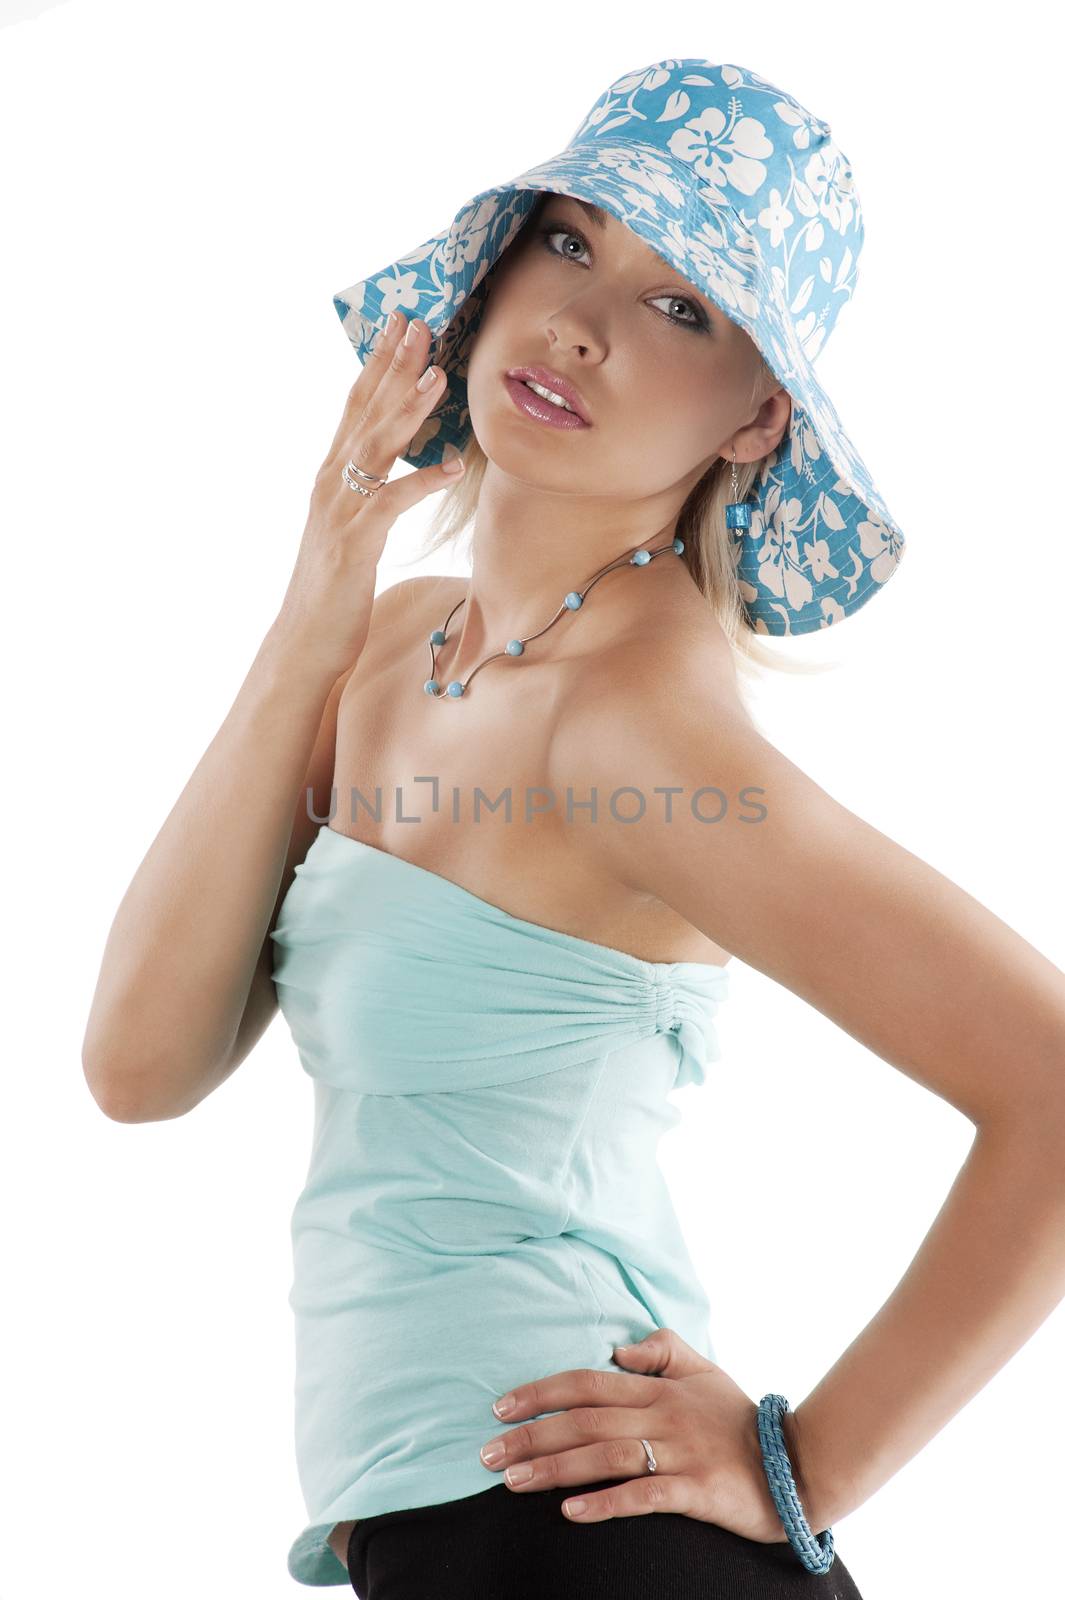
[82,617,350,1122]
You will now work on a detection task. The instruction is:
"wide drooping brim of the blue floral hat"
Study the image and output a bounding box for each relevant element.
[333,141,905,635]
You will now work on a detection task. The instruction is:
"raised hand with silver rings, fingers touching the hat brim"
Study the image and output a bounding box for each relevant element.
[273,312,457,677]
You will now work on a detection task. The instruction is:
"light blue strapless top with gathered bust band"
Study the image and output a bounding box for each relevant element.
[272,827,728,1586]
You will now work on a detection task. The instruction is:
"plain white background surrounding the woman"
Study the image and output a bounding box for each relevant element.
[0,0,1065,1600]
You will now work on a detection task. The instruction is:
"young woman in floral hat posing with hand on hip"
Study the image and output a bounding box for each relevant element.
[85,61,1065,1600]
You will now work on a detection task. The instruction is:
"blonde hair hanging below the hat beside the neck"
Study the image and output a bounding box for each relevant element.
[405,208,832,678]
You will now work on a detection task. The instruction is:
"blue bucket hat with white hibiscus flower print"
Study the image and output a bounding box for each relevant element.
[333,59,905,634]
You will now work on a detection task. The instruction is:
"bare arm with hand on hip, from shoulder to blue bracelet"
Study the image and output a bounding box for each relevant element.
[574,668,1065,1533]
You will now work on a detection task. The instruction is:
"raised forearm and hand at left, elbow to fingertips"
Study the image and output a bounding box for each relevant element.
[82,302,448,1122]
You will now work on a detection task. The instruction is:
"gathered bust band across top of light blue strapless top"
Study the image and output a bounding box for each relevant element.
[272,827,729,1094]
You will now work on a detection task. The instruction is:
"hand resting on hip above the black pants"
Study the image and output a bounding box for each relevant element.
[481,1328,806,1544]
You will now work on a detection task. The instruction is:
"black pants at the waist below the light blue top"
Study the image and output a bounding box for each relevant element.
[347,1478,862,1600]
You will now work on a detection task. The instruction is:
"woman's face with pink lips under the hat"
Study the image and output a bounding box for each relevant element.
[467,194,790,499]
